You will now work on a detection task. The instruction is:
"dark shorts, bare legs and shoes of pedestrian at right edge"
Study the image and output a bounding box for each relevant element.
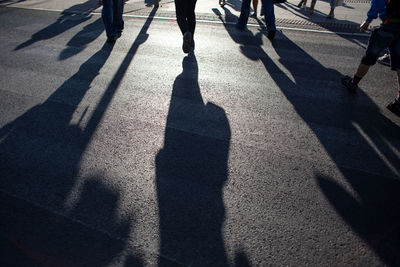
[342,23,400,116]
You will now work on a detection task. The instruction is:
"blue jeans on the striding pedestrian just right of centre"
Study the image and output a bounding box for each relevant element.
[237,0,276,31]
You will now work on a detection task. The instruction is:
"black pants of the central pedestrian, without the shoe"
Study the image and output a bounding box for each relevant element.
[175,0,197,36]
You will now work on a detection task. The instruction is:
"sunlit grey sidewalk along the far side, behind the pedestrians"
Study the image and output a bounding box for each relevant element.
[3,0,379,32]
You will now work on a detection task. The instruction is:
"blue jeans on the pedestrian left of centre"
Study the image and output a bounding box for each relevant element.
[101,0,124,38]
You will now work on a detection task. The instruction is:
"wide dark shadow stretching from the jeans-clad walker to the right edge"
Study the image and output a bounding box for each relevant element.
[222,17,400,266]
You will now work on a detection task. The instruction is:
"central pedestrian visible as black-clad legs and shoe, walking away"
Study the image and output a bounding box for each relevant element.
[175,0,197,54]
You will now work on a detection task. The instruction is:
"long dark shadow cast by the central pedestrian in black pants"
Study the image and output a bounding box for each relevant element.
[155,54,231,266]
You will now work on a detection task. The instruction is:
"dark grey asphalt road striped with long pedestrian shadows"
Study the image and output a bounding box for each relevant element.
[0,4,400,266]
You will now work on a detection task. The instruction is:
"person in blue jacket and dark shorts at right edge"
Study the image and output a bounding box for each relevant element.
[341,0,400,116]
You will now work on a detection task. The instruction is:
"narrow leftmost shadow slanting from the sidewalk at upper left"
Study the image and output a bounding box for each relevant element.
[14,0,98,51]
